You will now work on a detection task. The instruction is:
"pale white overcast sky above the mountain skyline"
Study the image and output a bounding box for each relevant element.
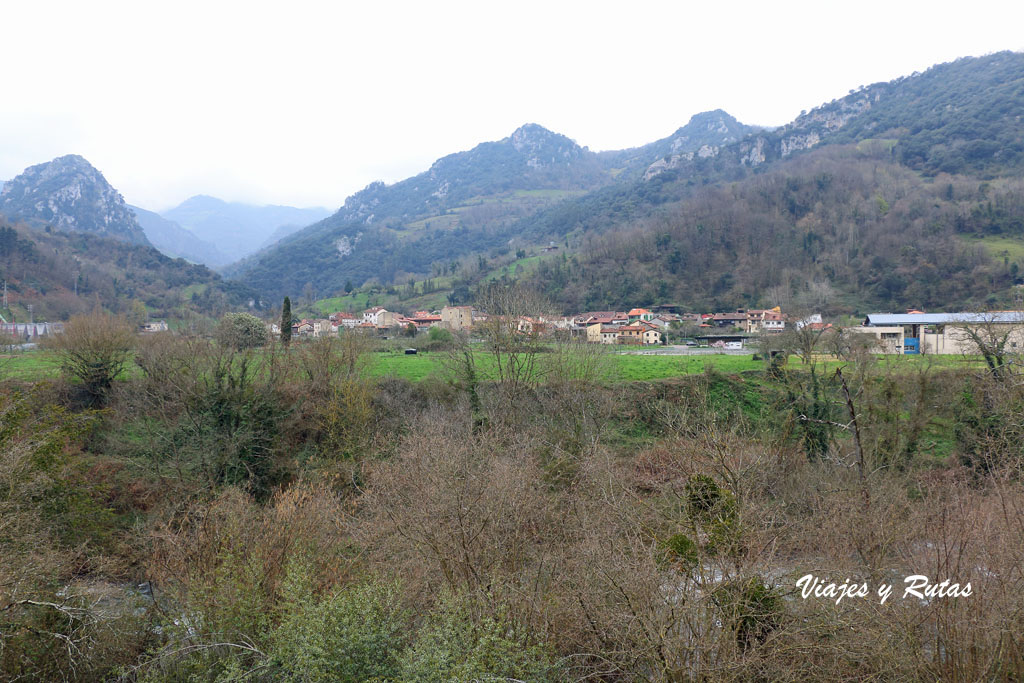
[0,0,1024,211]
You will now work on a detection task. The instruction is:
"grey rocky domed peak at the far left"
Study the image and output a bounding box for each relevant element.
[0,155,148,245]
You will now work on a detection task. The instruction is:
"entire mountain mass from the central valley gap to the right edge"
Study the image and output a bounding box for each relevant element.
[227,52,1024,310]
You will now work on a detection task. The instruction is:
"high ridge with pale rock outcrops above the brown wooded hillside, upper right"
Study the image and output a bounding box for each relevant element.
[646,52,1024,182]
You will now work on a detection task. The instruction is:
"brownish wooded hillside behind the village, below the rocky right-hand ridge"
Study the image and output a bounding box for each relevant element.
[520,145,1024,312]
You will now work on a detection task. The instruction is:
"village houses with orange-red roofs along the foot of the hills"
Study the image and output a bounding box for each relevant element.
[278,306,785,348]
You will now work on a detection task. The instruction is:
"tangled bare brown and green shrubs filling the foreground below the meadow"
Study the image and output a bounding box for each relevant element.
[0,319,1024,681]
